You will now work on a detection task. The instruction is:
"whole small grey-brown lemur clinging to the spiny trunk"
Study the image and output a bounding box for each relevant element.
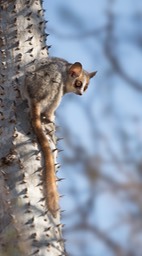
[24,58,96,217]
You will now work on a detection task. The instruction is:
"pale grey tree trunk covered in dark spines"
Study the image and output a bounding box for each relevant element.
[0,0,65,256]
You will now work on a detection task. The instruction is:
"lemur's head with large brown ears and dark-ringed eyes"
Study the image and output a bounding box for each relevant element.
[65,62,97,95]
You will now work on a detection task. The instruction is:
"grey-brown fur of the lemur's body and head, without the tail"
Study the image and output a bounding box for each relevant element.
[25,58,95,121]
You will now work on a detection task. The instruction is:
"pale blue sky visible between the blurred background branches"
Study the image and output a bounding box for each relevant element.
[44,0,142,256]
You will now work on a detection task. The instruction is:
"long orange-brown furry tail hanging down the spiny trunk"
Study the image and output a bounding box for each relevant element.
[31,102,59,217]
